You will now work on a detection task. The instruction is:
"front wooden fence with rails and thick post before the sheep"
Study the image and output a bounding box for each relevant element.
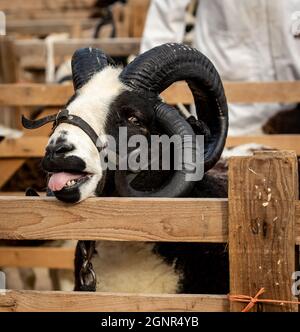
[0,151,300,312]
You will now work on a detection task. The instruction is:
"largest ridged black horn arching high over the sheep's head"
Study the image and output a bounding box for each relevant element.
[120,44,228,171]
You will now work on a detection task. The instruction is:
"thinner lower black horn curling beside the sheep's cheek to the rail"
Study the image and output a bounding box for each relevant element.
[115,102,201,197]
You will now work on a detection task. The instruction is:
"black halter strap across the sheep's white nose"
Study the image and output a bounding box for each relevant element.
[22,108,103,152]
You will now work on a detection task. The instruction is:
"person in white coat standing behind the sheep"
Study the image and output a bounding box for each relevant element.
[141,0,300,136]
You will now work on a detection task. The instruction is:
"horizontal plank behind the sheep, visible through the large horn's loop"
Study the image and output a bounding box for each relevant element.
[0,81,300,106]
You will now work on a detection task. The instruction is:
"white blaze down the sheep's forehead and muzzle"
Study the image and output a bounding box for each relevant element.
[48,66,127,200]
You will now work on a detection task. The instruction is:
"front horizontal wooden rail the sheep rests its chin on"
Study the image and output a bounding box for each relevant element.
[0,196,228,242]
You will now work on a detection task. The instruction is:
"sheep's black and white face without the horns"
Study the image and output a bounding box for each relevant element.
[42,67,153,203]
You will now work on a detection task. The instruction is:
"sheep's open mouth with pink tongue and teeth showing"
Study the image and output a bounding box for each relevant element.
[48,172,92,192]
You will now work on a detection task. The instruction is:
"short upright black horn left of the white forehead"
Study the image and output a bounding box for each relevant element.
[72,47,114,91]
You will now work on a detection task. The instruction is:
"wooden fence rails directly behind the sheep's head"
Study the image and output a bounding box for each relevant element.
[0,81,300,188]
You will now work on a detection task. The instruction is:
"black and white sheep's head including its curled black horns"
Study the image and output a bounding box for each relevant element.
[24,44,228,202]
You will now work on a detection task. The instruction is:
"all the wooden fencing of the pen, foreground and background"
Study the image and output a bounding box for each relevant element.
[0,0,300,312]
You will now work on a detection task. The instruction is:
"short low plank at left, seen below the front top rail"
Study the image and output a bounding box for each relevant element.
[0,247,75,270]
